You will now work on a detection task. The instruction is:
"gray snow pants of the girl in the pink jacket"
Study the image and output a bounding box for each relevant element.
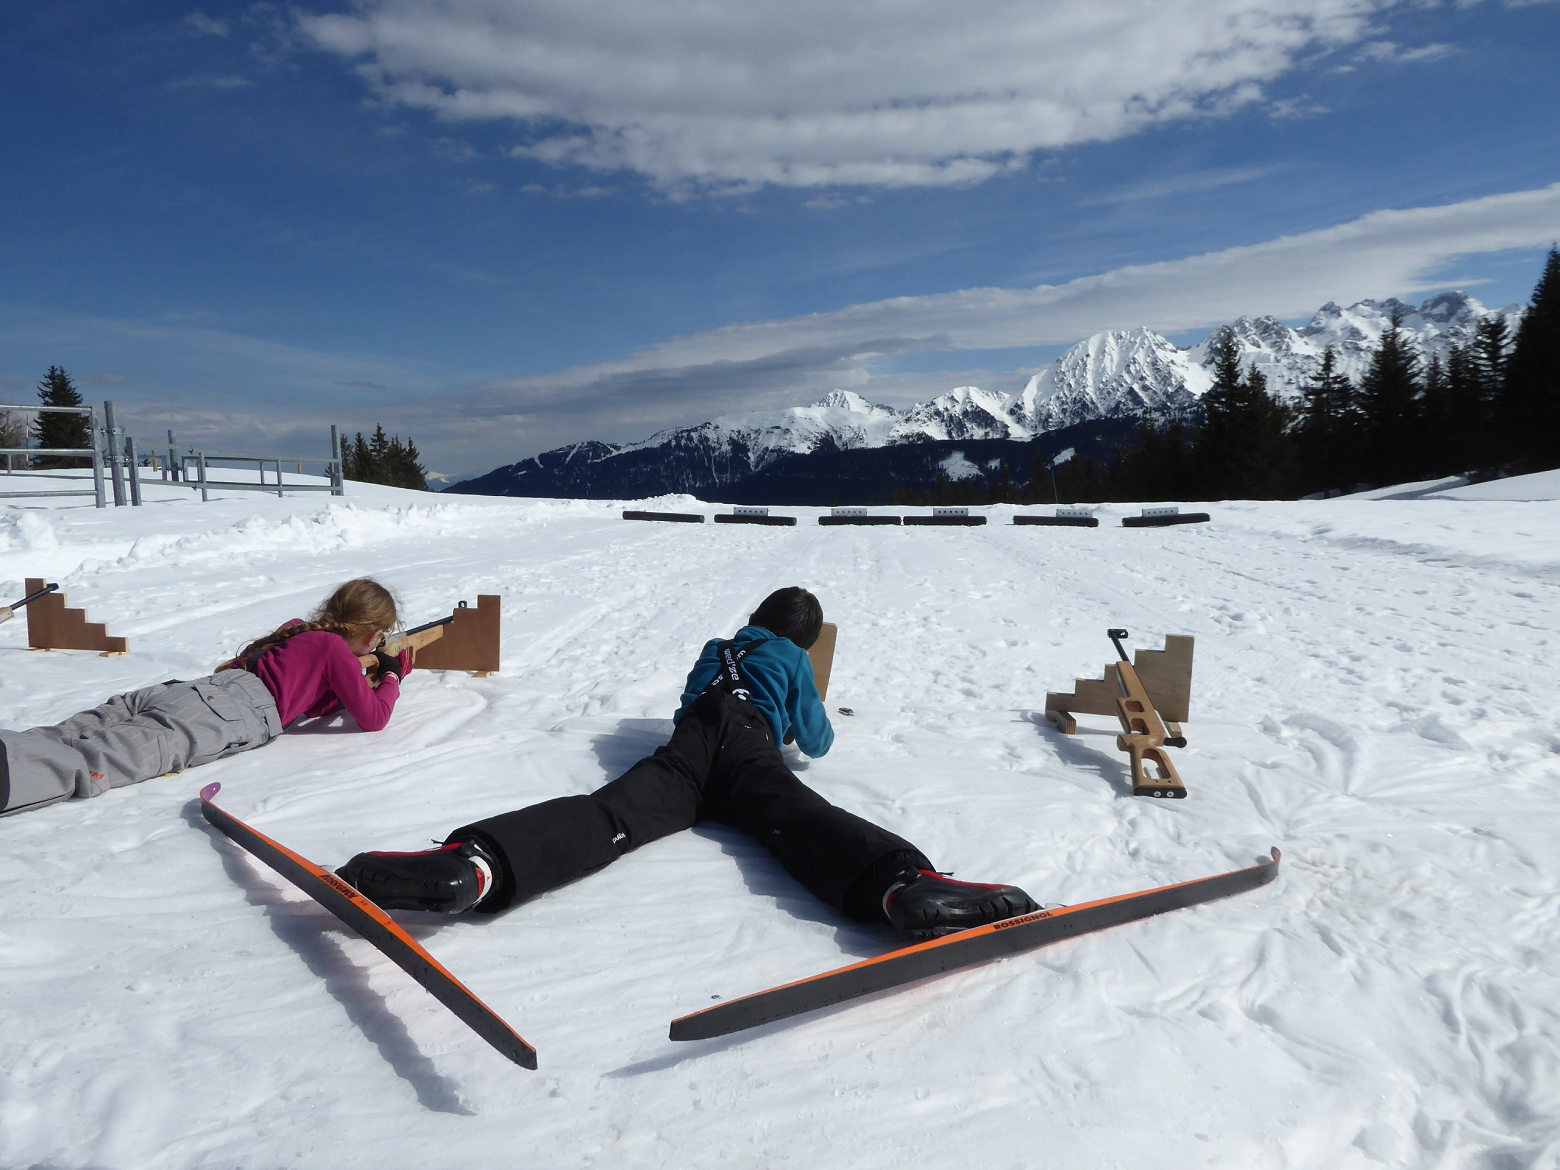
[0,669,282,816]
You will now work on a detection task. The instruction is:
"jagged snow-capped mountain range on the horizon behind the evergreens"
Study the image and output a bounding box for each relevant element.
[454,292,1523,496]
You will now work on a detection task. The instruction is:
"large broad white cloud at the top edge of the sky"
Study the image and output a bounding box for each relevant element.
[298,0,1392,192]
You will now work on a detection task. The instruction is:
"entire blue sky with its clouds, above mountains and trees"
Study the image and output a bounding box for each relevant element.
[0,0,1560,474]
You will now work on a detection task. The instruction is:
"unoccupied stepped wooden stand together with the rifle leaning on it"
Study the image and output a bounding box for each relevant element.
[1045,630,1197,797]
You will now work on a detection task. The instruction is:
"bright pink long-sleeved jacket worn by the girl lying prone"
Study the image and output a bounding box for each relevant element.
[254,622,412,732]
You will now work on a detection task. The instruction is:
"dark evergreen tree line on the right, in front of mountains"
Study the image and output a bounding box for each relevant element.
[889,248,1560,504]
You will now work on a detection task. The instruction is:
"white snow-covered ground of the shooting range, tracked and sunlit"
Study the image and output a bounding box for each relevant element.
[0,476,1560,1170]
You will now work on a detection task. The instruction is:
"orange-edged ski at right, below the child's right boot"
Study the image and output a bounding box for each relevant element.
[671,849,1281,1041]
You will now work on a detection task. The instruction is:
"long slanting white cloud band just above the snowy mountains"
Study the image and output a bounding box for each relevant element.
[458,183,1560,424]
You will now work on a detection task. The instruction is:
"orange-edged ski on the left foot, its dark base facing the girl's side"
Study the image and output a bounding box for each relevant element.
[200,785,537,1069]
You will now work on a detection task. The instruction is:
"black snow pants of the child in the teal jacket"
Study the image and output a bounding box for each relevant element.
[446,688,931,922]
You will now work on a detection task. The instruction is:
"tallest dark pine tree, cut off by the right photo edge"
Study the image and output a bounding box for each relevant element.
[1499,248,1560,471]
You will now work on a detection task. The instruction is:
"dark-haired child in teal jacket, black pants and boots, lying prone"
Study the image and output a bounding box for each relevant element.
[347,588,1037,941]
